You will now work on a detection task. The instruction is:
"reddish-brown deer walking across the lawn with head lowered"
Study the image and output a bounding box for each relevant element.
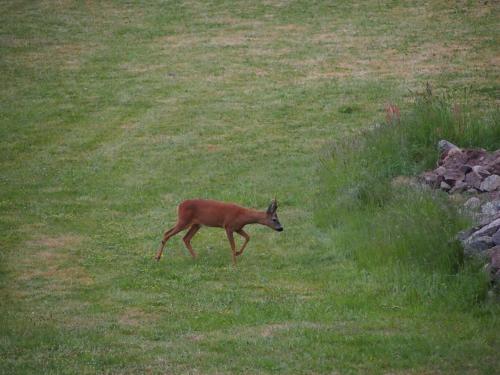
[155,198,283,266]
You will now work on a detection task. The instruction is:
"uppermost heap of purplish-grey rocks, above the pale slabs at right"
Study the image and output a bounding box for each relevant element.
[421,140,500,194]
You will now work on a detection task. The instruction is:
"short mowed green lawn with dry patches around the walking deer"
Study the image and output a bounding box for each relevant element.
[0,0,500,374]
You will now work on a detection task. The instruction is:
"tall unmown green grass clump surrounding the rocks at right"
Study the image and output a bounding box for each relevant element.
[316,93,500,306]
